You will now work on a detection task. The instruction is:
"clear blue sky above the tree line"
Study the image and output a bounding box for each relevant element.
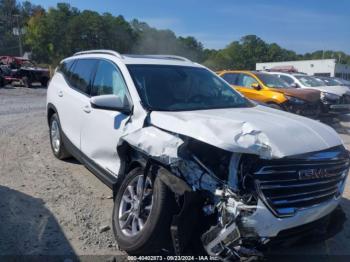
[26,0,350,54]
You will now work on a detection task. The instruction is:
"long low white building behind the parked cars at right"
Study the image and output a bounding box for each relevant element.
[256,59,350,80]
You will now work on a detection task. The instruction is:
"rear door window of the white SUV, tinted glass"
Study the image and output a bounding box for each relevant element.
[69,59,97,95]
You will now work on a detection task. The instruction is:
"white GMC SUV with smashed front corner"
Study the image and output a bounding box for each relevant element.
[47,50,349,260]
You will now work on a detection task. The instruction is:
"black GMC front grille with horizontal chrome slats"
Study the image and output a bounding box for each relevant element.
[254,148,349,217]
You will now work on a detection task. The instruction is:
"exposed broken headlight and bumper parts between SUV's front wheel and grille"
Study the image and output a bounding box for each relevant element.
[172,139,265,261]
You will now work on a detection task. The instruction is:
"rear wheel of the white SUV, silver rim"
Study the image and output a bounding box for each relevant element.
[50,113,71,160]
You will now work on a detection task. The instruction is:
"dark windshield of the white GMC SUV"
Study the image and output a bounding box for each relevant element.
[128,65,253,111]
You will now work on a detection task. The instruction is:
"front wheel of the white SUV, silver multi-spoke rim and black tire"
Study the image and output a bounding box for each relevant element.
[113,167,175,255]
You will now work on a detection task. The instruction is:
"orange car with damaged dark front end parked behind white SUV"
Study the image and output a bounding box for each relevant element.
[217,70,321,116]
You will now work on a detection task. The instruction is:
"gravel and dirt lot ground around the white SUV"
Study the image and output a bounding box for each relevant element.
[0,88,350,262]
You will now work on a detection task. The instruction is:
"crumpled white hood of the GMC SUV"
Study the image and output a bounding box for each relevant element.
[150,106,342,159]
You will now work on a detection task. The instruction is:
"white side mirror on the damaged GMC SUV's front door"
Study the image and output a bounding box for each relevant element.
[90,95,131,115]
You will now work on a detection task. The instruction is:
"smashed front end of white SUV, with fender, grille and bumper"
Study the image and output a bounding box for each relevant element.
[121,126,349,261]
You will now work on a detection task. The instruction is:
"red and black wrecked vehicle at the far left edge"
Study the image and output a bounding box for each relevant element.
[0,56,50,87]
